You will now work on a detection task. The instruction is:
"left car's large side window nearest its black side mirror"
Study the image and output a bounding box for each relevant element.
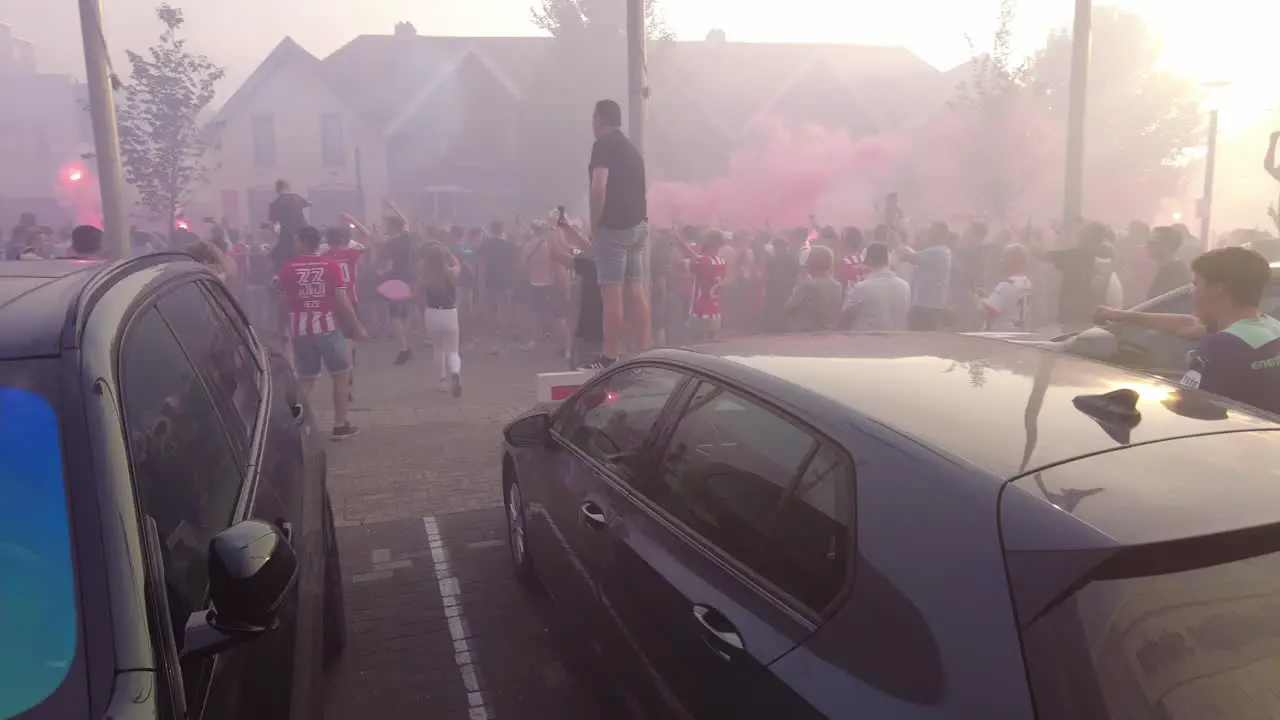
[119,309,243,643]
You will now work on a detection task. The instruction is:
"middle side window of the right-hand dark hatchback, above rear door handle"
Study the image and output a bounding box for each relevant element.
[643,383,817,579]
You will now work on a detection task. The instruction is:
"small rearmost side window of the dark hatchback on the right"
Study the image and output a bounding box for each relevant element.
[760,445,854,611]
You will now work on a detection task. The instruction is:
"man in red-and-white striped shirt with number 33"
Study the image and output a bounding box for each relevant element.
[274,225,367,441]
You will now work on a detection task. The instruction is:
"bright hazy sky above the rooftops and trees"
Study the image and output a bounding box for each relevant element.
[0,0,1280,120]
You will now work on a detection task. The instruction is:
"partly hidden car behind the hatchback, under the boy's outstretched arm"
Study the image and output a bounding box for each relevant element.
[974,263,1280,379]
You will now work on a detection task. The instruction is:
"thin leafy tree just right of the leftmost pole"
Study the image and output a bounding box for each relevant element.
[118,3,225,231]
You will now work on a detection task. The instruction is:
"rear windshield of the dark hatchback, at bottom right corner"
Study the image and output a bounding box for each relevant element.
[1023,555,1280,720]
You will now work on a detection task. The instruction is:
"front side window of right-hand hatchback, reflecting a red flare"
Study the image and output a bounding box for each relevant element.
[557,366,685,478]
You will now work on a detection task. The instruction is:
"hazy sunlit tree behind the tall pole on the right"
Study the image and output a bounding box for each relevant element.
[1027,6,1204,222]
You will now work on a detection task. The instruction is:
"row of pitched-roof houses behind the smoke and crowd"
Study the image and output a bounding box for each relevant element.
[201,23,963,227]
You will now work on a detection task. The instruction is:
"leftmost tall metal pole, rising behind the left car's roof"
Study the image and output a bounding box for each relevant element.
[79,0,129,259]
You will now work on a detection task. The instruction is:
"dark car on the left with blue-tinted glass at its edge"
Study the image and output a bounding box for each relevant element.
[0,254,344,720]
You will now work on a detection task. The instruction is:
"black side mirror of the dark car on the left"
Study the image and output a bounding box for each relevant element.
[182,520,298,660]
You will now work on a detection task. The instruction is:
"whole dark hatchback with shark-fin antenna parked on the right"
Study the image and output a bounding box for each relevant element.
[502,333,1280,720]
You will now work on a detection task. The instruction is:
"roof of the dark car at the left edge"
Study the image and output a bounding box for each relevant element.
[0,252,193,360]
